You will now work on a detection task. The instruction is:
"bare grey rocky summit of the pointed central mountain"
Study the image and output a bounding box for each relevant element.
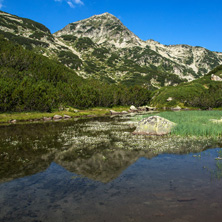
[55,12,143,48]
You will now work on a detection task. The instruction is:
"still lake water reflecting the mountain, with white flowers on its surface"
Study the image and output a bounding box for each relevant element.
[0,112,222,222]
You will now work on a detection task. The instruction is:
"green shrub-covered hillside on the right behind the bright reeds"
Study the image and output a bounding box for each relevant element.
[151,66,222,109]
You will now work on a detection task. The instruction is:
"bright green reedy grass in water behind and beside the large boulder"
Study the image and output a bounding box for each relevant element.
[134,111,222,138]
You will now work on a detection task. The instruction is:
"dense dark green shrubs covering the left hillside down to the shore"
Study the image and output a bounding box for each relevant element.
[0,36,151,112]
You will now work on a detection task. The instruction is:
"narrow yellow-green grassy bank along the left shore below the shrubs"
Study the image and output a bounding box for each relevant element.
[0,106,129,125]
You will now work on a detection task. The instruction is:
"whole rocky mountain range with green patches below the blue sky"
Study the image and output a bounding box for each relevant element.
[0,11,222,88]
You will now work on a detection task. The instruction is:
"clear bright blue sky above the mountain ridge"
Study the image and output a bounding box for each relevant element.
[0,0,222,52]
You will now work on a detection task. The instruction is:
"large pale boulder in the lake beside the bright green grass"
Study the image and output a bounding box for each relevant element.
[133,116,176,136]
